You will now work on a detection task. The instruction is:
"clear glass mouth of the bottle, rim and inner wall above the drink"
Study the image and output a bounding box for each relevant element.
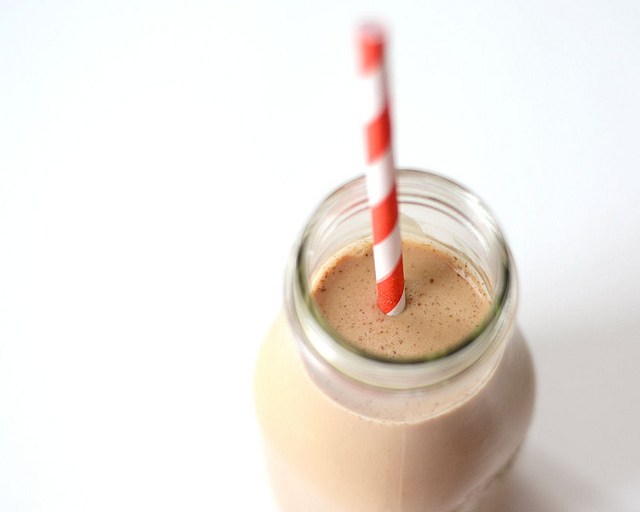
[285,170,517,390]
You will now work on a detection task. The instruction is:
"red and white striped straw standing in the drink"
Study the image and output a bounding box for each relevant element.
[358,24,405,316]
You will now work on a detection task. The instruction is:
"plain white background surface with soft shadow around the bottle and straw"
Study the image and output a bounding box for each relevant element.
[0,0,640,512]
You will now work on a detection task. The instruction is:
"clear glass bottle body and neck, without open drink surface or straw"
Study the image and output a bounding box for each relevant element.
[255,171,534,512]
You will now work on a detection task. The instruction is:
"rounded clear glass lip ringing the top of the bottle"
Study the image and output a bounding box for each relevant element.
[285,170,517,390]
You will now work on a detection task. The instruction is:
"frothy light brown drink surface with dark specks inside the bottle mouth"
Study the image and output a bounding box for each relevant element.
[312,239,491,361]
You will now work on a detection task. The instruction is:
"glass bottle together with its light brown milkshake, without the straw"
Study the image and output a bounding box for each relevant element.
[255,171,533,512]
